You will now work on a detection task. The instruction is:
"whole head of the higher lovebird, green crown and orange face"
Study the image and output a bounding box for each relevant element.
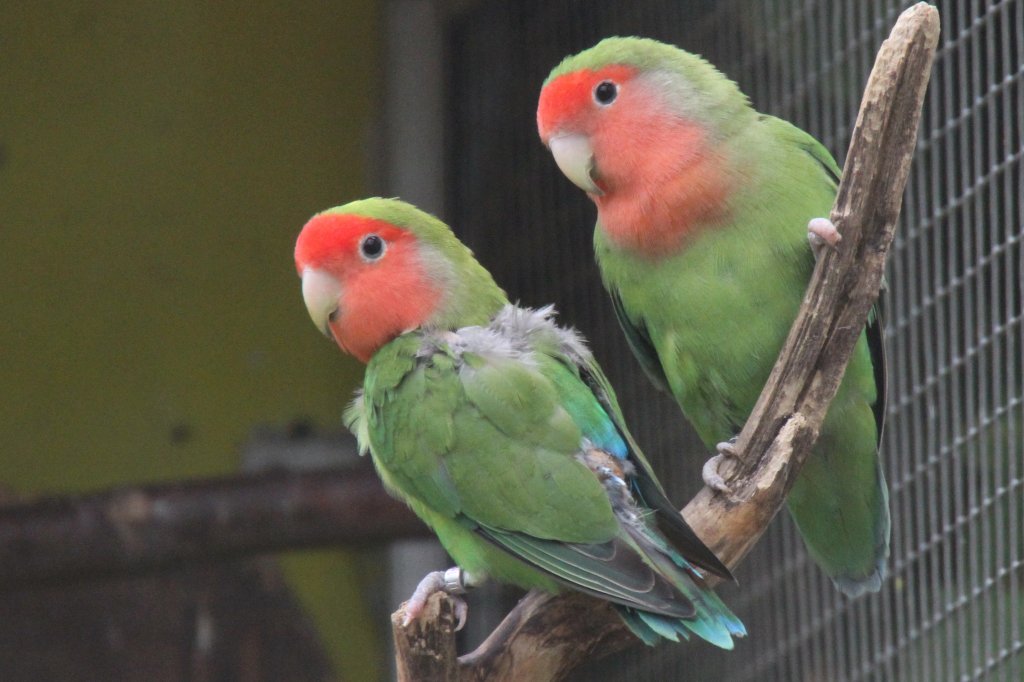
[537,38,753,249]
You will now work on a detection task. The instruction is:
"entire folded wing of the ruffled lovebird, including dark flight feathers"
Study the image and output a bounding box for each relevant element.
[357,323,720,617]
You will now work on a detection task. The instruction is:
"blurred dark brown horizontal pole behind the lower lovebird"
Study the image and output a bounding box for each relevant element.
[0,464,428,590]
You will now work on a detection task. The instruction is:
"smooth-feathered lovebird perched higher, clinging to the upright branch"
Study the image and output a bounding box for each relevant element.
[537,38,890,596]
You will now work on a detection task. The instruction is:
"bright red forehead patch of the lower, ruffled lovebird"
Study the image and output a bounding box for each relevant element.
[295,213,410,274]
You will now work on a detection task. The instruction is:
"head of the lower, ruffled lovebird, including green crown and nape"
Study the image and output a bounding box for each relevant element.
[295,199,504,363]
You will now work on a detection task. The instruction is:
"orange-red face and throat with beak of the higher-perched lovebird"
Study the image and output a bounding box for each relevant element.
[537,65,729,257]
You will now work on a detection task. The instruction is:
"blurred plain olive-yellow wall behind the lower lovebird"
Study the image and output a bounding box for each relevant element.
[0,0,379,679]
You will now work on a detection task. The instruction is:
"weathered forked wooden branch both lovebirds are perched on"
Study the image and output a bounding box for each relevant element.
[394,2,939,682]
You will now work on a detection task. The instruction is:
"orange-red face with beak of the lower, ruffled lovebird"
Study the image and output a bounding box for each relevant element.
[295,213,440,363]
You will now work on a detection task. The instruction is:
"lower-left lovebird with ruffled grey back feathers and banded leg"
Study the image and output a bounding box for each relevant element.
[295,199,745,649]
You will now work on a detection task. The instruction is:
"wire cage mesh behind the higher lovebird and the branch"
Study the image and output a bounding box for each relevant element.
[447,0,1024,682]
